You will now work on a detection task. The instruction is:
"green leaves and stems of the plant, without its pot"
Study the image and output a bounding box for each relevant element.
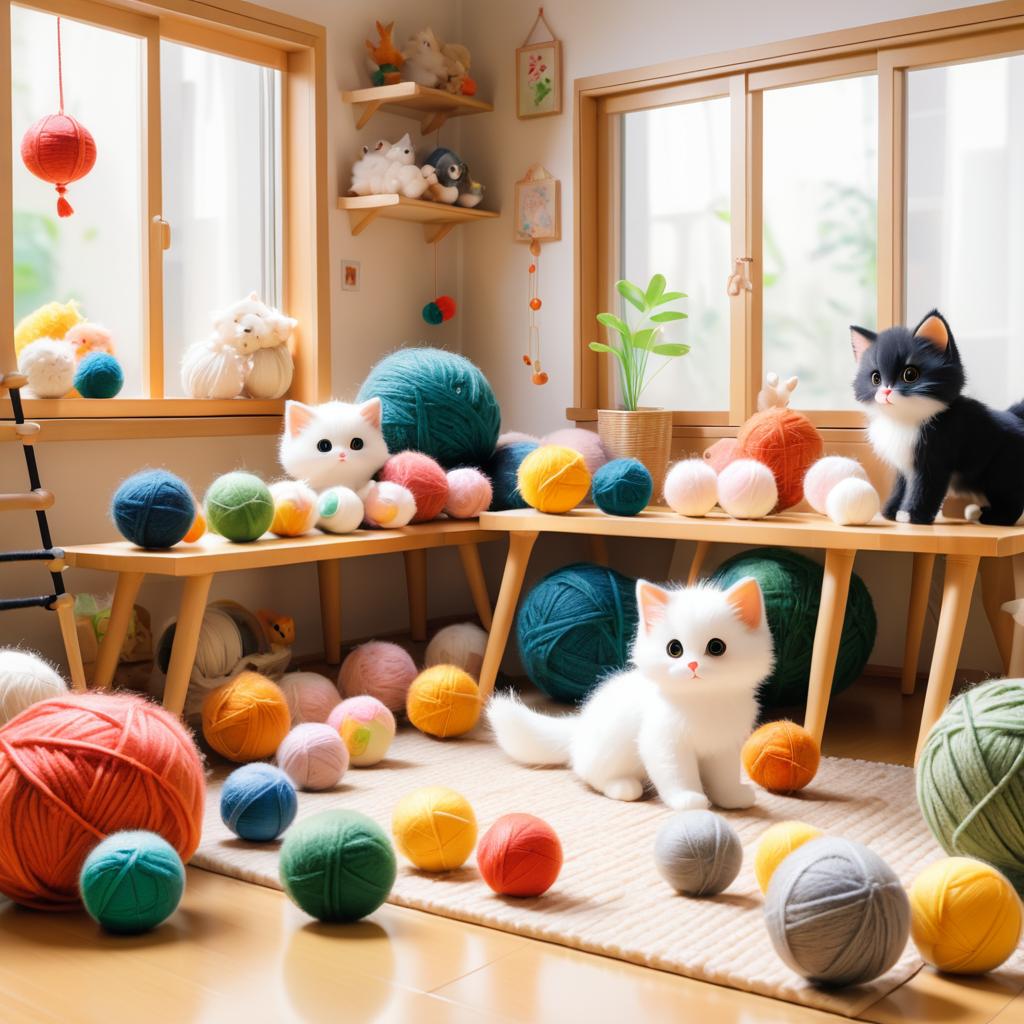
[590,273,690,412]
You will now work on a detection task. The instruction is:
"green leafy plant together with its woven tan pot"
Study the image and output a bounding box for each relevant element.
[590,273,690,494]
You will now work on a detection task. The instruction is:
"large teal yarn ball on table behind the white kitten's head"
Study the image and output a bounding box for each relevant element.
[358,348,502,469]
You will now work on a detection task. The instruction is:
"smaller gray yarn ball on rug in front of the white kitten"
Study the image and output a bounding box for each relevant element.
[654,811,743,896]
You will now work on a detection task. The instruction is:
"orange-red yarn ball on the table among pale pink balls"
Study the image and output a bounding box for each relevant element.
[736,406,825,512]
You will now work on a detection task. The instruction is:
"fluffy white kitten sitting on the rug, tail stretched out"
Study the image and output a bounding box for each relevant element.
[487,579,774,811]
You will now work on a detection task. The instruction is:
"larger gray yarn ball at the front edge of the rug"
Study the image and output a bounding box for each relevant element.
[765,837,910,985]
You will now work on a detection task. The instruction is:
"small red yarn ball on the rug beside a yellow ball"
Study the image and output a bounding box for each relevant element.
[476,814,562,896]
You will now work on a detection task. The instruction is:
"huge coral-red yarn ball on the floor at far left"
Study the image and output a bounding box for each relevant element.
[0,692,206,909]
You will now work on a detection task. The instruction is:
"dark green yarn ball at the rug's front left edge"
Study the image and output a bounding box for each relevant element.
[281,811,397,923]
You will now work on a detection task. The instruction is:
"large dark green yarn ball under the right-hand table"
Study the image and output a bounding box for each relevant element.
[714,548,878,708]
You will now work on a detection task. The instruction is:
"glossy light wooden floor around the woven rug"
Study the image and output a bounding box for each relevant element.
[0,680,1024,1024]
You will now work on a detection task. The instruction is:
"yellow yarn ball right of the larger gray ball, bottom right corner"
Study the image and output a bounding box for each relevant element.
[910,857,1022,974]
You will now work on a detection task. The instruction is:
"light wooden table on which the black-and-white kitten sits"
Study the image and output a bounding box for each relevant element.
[480,508,1024,752]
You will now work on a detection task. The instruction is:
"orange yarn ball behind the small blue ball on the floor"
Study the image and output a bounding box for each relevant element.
[203,671,291,762]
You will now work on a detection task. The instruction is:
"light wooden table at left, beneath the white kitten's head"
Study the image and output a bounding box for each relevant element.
[65,520,502,714]
